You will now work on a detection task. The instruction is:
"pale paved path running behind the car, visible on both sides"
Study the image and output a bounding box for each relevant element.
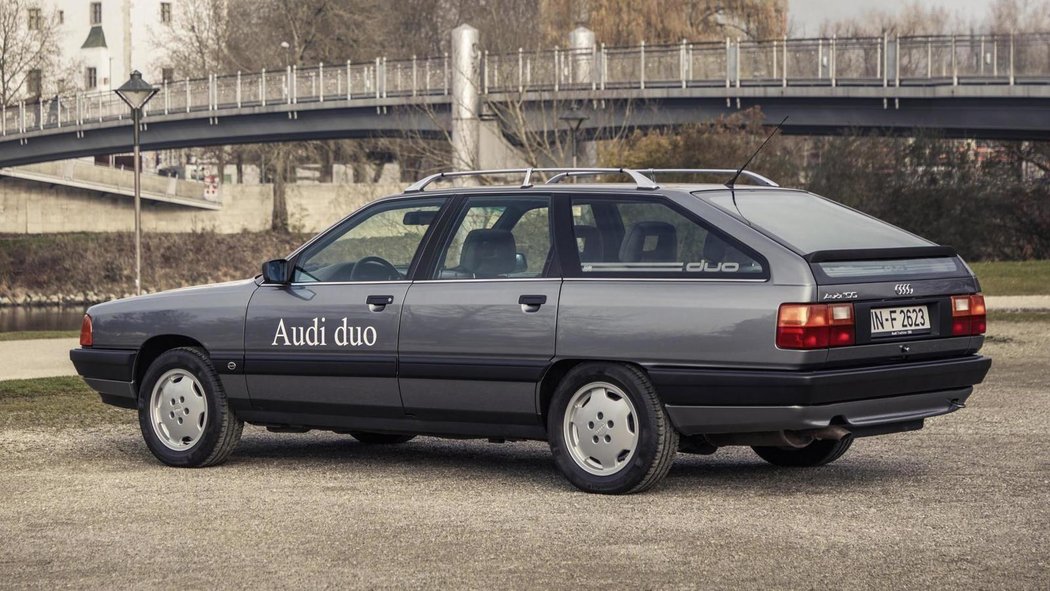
[0,295,1050,381]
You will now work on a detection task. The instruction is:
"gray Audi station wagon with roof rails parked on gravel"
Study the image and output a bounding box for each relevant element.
[70,169,991,493]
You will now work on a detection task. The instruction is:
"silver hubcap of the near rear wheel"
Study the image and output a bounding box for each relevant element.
[563,382,638,477]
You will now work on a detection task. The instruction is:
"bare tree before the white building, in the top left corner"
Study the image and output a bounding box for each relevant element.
[0,0,69,105]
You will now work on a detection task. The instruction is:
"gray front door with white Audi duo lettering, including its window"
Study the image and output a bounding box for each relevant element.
[245,197,445,417]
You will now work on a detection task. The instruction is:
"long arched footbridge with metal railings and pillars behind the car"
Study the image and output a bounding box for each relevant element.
[0,30,1050,167]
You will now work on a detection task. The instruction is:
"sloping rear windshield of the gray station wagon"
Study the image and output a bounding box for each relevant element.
[704,189,933,254]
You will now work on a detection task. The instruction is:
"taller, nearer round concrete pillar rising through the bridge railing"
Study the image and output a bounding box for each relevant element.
[452,23,481,175]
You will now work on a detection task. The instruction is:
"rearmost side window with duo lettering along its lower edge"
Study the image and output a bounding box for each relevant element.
[572,197,768,279]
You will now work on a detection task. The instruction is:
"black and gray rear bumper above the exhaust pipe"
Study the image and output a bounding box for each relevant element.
[649,356,991,435]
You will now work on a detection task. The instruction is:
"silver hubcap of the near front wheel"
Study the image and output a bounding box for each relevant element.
[149,370,208,451]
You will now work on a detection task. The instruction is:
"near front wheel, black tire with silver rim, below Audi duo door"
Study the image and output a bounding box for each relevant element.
[139,347,245,468]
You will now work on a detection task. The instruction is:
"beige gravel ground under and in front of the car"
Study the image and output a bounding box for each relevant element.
[0,323,1050,589]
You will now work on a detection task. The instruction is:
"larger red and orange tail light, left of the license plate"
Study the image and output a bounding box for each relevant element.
[777,303,856,350]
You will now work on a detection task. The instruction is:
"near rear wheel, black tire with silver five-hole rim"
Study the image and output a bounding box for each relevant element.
[547,363,678,494]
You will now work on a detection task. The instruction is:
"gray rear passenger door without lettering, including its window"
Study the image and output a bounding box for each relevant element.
[399,195,561,426]
